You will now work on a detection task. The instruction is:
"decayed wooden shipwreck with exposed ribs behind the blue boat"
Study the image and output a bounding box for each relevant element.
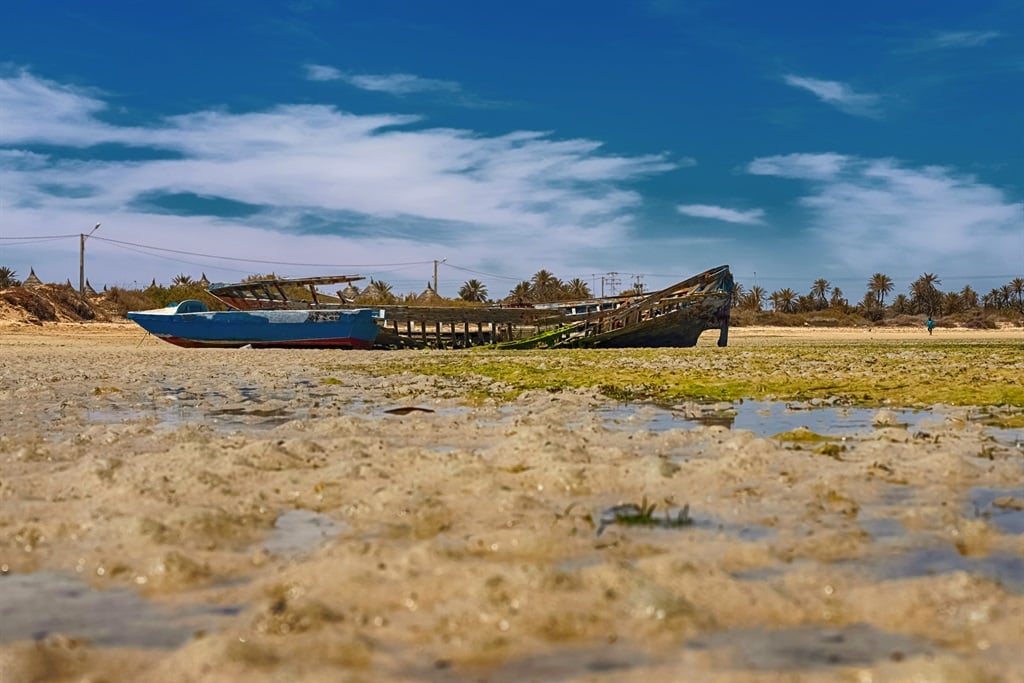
[208,265,733,348]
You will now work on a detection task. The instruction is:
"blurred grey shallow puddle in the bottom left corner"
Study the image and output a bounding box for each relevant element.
[0,571,242,649]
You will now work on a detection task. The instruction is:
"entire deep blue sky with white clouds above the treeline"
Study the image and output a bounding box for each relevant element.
[0,0,1024,301]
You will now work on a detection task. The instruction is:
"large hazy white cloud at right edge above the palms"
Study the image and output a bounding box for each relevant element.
[748,154,1024,275]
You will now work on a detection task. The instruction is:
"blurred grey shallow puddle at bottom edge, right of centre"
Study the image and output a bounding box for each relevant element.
[686,624,938,671]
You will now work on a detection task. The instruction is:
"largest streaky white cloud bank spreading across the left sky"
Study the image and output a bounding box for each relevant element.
[0,74,677,289]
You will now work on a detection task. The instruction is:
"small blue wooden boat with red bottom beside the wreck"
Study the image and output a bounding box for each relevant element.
[128,301,379,348]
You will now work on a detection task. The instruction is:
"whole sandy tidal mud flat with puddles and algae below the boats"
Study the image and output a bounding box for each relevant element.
[0,325,1024,683]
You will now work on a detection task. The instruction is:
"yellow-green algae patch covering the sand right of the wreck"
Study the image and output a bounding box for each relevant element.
[333,340,1024,407]
